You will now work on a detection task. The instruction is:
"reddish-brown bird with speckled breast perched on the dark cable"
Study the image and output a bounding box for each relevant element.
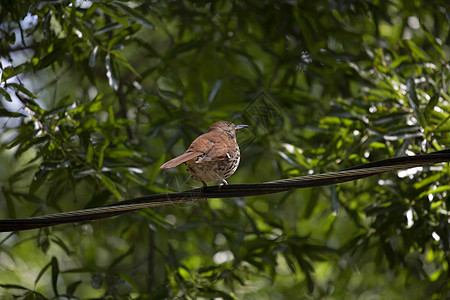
[160,121,248,188]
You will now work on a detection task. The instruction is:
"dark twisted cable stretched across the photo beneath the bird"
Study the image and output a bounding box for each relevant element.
[0,150,450,232]
